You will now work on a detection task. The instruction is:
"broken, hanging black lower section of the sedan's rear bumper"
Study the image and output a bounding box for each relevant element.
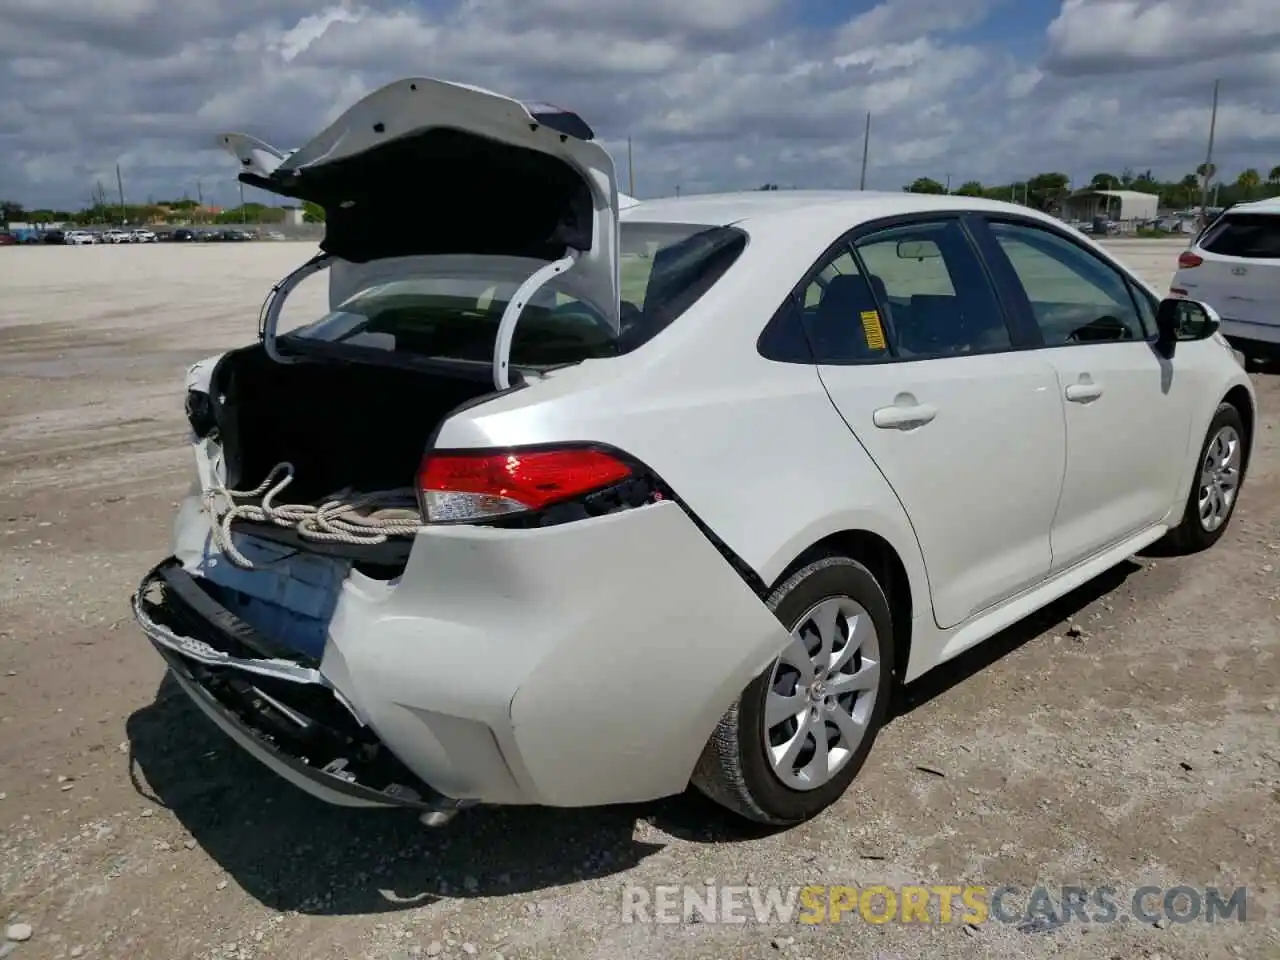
[133,559,475,813]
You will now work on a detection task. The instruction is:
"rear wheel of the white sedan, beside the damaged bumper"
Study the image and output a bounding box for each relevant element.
[692,556,893,826]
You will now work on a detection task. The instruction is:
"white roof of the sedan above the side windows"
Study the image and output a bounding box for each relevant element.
[621,189,1053,229]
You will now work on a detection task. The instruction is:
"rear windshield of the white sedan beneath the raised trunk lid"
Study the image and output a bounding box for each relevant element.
[282,223,746,367]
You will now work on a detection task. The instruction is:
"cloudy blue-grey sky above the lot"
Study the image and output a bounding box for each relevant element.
[0,0,1280,209]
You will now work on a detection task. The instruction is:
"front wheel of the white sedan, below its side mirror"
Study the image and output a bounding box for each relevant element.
[1165,403,1247,554]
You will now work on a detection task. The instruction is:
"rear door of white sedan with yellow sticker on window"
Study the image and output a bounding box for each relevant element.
[796,215,1066,628]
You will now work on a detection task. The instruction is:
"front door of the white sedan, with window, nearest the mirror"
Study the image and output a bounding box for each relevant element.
[988,218,1194,570]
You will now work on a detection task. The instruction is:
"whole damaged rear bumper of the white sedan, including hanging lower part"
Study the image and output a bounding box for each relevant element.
[136,497,788,809]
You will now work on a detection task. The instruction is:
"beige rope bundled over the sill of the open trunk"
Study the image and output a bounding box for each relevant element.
[204,462,422,570]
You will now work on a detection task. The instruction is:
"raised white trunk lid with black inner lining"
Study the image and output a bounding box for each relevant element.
[219,78,621,330]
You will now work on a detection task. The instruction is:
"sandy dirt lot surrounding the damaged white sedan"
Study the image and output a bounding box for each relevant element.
[0,242,1280,960]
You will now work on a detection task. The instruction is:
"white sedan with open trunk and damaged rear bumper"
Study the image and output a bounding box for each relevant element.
[134,78,1256,824]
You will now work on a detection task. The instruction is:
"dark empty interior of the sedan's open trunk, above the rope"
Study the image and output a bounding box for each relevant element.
[212,346,493,503]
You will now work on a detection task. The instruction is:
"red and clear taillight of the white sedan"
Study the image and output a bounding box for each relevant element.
[417,447,631,522]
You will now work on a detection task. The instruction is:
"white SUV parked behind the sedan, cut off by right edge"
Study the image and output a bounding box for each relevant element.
[1170,198,1280,361]
